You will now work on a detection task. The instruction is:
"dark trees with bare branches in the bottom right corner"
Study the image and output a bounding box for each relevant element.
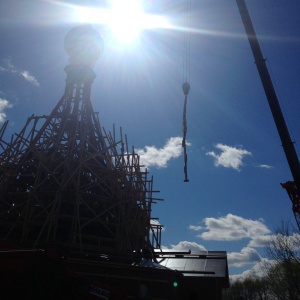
[223,225,300,300]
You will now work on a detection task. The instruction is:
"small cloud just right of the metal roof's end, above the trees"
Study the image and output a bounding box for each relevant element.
[227,247,261,267]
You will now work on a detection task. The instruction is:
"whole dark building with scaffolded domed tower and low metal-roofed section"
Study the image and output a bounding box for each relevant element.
[0,25,229,300]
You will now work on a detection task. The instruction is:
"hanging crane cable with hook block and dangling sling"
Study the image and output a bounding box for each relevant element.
[182,0,190,182]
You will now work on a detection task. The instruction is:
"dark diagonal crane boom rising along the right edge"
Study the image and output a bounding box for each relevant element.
[236,0,300,229]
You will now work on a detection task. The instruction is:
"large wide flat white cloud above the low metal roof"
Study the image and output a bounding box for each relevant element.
[198,214,270,241]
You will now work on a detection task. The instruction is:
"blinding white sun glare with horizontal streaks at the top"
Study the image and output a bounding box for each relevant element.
[75,0,169,44]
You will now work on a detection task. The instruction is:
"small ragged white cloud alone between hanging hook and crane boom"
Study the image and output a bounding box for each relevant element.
[206,143,252,171]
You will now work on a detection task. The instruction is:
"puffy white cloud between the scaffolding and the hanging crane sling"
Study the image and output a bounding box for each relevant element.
[136,137,190,168]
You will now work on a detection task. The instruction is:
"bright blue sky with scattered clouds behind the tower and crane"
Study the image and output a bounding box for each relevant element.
[0,0,300,277]
